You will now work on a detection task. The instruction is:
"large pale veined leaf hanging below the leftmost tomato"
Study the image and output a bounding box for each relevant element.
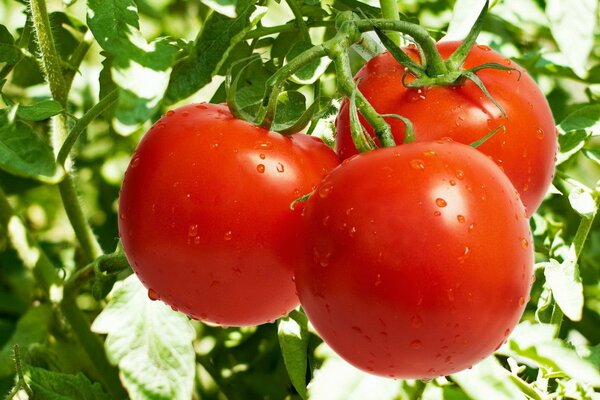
[92,275,195,400]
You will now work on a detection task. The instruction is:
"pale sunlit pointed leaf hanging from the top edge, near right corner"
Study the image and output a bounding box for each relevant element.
[546,0,598,77]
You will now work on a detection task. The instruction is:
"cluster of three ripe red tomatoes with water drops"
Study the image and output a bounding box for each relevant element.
[119,43,556,378]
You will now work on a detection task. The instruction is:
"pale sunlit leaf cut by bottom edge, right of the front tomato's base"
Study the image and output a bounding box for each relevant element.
[452,356,527,400]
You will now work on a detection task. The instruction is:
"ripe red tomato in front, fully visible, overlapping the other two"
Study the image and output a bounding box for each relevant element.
[296,141,533,378]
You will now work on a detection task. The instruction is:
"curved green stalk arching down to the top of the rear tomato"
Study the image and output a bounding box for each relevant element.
[355,19,448,77]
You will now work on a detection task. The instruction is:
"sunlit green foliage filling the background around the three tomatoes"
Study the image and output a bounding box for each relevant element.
[0,0,600,400]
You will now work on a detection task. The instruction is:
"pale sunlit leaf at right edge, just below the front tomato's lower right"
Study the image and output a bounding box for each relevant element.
[501,321,600,386]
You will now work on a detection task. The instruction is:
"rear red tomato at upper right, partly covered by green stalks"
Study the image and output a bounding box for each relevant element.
[336,42,557,216]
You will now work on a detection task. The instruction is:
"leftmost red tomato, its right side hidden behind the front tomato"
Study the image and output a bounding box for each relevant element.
[119,104,338,326]
